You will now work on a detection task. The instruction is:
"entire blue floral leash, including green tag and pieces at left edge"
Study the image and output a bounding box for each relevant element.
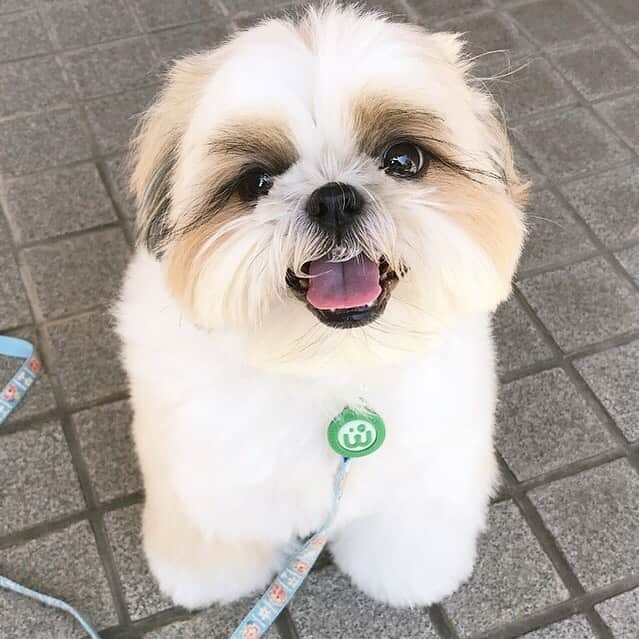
[0,335,386,639]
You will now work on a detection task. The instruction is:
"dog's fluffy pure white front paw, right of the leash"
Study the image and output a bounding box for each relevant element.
[331,504,482,606]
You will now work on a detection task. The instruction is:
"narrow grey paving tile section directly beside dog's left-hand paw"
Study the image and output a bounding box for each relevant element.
[104,505,172,619]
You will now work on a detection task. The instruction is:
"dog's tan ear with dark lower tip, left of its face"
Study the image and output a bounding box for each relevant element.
[130,53,215,255]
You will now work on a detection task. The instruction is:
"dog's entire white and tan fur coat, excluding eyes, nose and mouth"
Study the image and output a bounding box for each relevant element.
[117,5,526,607]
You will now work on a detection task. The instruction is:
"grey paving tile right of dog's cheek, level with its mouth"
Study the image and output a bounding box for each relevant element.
[521,257,639,350]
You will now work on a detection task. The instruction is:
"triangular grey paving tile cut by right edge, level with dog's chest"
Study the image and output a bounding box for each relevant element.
[575,341,639,440]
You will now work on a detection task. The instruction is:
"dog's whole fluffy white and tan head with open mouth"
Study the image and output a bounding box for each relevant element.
[133,8,525,366]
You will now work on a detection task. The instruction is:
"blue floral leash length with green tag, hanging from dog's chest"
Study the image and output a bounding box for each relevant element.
[229,407,386,639]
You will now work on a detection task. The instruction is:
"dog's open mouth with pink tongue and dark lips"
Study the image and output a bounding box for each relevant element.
[286,254,397,328]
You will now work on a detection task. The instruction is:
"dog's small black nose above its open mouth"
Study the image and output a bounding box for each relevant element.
[306,182,363,241]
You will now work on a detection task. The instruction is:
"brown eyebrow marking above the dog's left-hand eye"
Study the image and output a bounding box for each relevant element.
[209,119,299,174]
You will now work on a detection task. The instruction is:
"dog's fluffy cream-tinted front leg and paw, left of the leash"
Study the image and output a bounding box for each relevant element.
[143,494,281,609]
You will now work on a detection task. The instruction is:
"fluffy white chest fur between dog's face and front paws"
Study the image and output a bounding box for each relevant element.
[119,254,495,543]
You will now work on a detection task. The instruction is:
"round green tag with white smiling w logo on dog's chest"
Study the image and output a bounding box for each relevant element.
[328,407,386,457]
